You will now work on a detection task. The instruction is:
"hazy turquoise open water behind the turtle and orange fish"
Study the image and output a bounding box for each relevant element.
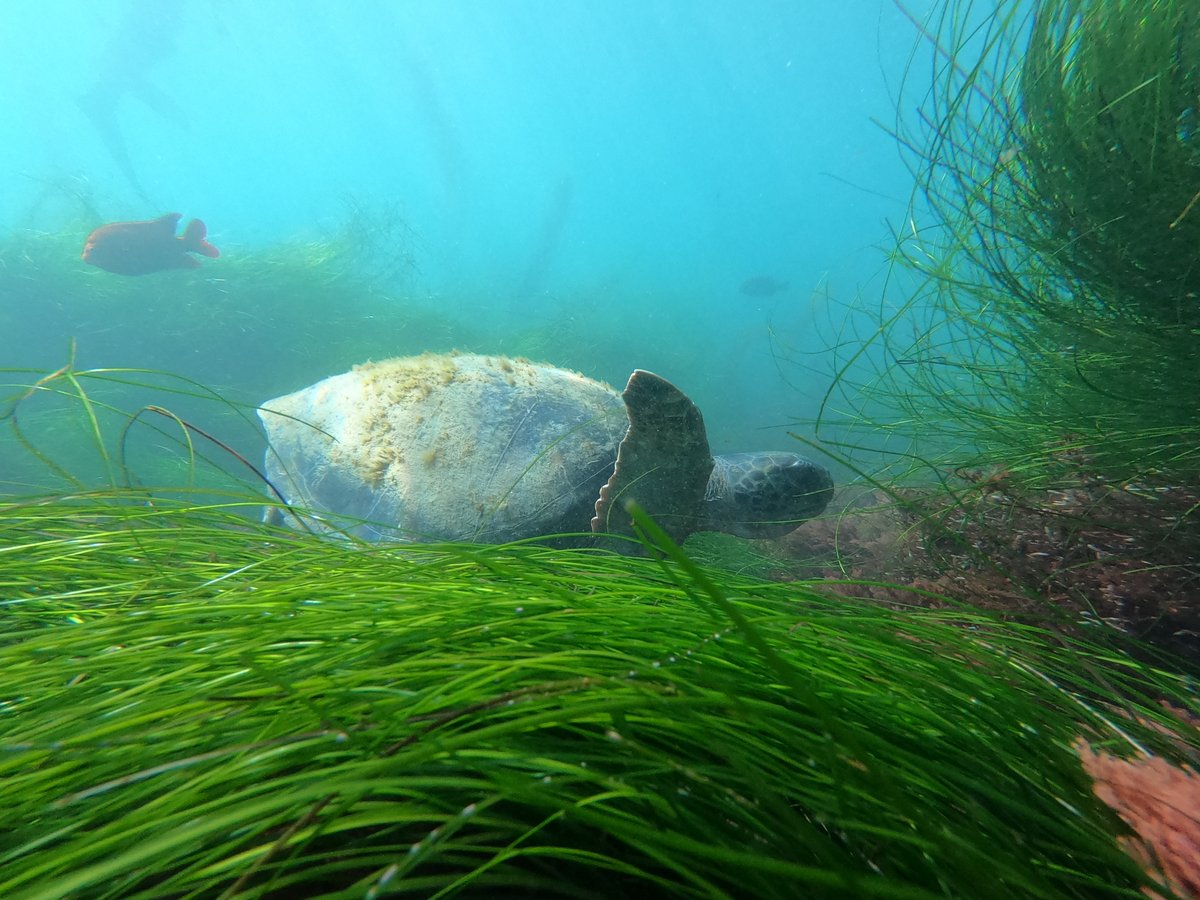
[0,0,931,494]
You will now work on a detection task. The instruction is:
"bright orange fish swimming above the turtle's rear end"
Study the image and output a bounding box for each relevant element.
[83,212,221,275]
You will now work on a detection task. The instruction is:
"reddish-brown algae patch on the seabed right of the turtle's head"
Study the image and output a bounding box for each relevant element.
[780,470,1200,659]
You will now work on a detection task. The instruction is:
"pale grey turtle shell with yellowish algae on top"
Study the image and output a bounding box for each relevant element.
[259,354,629,542]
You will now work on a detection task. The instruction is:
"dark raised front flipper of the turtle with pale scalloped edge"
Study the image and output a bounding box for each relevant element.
[592,368,713,542]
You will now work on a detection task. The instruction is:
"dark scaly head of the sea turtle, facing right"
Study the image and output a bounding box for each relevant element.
[701,451,833,538]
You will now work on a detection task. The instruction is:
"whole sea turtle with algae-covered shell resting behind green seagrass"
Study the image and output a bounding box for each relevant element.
[259,354,833,542]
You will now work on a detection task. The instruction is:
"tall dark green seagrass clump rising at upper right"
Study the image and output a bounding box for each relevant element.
[820,0,1200,487]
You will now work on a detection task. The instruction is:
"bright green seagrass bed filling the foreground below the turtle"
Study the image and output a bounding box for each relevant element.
[0,492,1196,898]
